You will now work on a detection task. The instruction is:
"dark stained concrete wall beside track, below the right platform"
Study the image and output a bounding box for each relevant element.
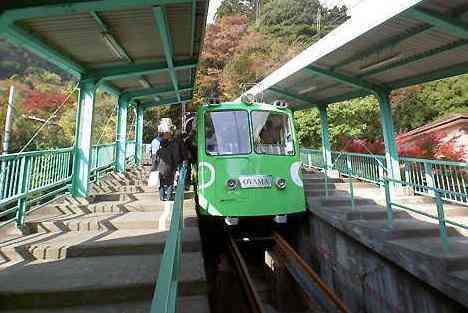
[296,214,466,313]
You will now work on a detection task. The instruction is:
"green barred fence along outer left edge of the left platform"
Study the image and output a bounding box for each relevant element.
[0,141,134,226]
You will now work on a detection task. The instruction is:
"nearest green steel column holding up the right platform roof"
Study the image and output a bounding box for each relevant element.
[377,92,401,186]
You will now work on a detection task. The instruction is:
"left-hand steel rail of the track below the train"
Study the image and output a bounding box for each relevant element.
[228,235,266,313]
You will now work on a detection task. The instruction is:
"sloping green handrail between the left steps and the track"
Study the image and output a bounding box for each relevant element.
[151,166,187,313]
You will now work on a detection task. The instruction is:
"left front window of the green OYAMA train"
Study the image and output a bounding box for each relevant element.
[205,111,251,155]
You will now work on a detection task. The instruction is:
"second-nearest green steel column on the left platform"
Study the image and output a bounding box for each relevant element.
[115,97,128,173]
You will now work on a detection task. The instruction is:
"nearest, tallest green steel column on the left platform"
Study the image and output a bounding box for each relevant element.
[72,80,96,197]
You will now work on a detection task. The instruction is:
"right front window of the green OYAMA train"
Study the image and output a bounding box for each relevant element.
[252,111,294,155]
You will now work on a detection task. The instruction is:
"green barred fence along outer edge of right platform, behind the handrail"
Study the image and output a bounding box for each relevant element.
[301,149,468,204]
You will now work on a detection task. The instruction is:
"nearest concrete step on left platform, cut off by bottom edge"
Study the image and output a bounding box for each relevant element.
[7,296,210,313]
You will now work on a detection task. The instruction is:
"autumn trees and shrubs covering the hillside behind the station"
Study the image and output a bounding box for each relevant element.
[0,0,468,156]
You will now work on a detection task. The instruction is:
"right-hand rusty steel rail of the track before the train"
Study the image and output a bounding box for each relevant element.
[273,232,351,313]
